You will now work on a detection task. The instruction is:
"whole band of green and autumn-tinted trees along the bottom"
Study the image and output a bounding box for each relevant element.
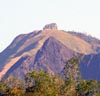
[0,58,100,96]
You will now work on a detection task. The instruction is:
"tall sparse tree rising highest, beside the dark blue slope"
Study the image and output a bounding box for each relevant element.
[63,57,81,83]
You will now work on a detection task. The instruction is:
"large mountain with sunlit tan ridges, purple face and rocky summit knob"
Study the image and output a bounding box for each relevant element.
[0,23,99,78]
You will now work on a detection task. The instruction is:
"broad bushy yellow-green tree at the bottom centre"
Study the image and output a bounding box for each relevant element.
[26,70,63,96]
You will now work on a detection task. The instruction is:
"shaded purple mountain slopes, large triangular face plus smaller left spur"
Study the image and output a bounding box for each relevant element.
[5,37,78,78]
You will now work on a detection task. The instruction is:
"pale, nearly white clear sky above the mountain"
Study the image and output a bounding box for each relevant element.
[0,0,100,52]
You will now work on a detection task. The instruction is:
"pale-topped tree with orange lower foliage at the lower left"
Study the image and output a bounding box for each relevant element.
[6,75,25,96]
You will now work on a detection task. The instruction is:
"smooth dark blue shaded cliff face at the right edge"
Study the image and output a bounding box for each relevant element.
[80,54,100,81]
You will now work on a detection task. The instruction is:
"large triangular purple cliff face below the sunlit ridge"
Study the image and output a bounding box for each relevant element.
[34,37,77,73]
